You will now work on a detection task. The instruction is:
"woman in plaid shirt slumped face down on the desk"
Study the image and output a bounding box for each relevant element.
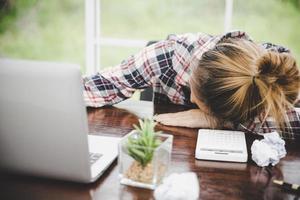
[84,31,300,137]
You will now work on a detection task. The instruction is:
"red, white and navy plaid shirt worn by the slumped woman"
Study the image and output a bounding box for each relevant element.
[83,31,300,137]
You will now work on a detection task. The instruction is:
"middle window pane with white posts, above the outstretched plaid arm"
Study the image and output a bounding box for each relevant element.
[85,0,232,74]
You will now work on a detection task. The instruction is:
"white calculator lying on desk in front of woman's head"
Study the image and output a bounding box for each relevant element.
[195,129,248,162]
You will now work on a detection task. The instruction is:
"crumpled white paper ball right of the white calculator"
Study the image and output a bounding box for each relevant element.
[251,132,286,167]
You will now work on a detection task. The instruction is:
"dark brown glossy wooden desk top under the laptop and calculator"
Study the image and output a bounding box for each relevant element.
[0,102,300,200]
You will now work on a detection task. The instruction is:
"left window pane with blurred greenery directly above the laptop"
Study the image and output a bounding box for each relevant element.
[0,0,85,70]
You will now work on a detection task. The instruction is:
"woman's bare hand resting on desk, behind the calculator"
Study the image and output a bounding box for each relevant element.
[153,109,218,128]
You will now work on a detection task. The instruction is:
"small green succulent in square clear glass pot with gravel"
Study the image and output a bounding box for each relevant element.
[119,119,173,189]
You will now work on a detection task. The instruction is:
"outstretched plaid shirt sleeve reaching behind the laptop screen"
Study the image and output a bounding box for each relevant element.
[83,40,174,107]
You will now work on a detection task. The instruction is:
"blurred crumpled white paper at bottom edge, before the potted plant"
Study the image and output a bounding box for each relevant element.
[154,172,199,200]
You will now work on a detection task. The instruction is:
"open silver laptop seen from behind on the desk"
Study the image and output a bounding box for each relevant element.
[0,59,120,183]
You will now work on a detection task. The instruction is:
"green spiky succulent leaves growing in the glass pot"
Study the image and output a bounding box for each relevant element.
[127,119,161,167]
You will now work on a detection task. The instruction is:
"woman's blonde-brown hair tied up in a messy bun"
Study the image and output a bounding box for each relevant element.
[191,39,300,132]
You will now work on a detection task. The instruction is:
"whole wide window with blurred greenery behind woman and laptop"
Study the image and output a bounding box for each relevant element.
[0,0,300,72]
